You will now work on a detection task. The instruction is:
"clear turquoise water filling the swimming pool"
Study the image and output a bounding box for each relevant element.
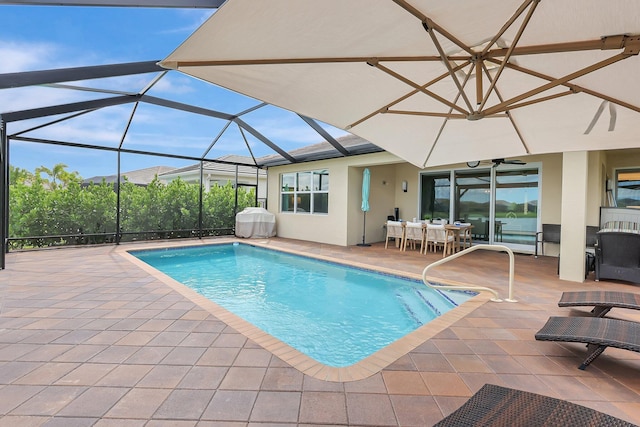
[131,243,473,367]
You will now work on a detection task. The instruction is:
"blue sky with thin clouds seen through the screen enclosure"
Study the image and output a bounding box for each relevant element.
[0,5,346,178]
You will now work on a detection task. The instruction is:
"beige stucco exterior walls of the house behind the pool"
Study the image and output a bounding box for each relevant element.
[268,150,640,255]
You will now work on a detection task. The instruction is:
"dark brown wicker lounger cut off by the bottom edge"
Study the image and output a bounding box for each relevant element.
[434,384,633,427]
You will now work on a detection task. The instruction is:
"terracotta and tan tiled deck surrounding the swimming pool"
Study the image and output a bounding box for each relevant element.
[0,238,640,427]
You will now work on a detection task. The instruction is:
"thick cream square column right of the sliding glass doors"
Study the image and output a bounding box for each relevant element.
[560,151,589,282]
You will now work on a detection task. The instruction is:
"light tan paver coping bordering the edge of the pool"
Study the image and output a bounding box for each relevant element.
[116,238,490,382]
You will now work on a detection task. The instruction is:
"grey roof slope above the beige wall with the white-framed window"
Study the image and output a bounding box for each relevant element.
[256,135,384,167]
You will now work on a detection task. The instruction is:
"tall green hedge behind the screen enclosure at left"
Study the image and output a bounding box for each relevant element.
[9,165,256,248]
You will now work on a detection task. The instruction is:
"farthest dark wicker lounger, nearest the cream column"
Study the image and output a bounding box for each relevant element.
[558,291,640,317]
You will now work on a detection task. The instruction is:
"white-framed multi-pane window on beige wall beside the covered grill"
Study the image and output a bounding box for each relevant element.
[280,170,329,214]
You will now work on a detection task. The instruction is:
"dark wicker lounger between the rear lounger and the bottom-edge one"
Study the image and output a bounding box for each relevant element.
[536,317,640,369]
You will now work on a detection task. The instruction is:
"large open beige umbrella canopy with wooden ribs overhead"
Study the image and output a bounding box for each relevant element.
[161,0,640,167]
